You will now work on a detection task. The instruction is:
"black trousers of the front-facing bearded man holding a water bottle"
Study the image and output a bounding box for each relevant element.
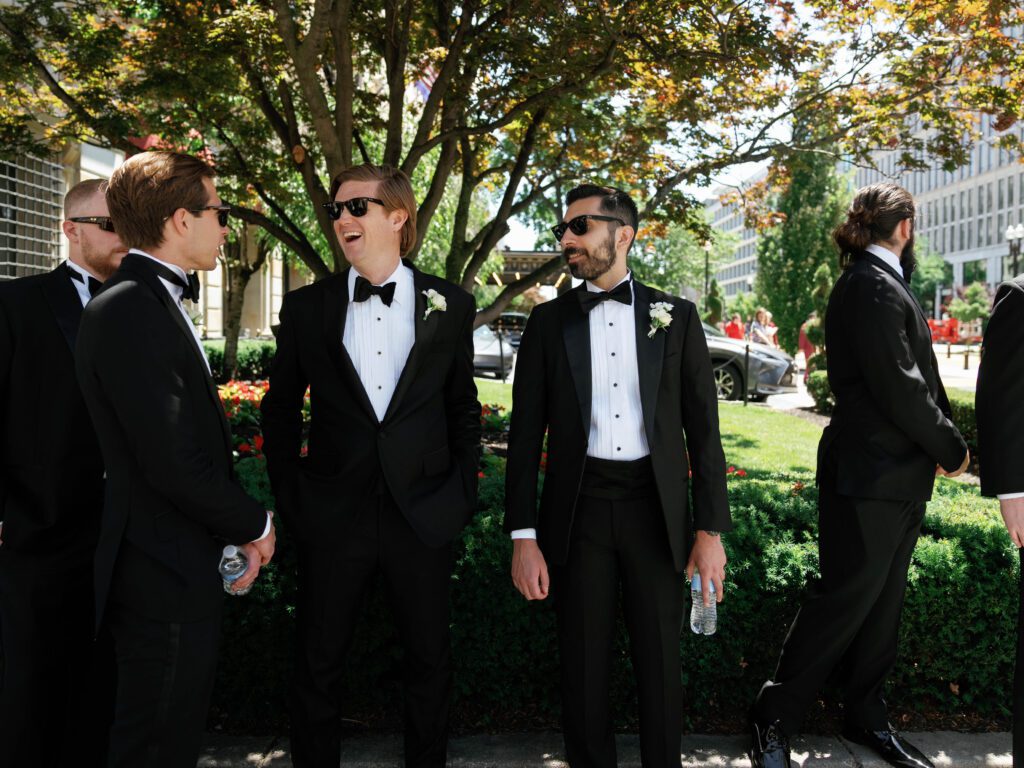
[551,496,686,768]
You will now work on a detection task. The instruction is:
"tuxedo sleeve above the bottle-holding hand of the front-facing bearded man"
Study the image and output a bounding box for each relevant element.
[679,302,732,530]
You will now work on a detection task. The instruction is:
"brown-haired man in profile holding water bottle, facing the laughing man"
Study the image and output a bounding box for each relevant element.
[76,152,274,768]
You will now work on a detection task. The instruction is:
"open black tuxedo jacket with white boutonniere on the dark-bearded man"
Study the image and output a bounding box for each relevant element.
[505,282,732,571]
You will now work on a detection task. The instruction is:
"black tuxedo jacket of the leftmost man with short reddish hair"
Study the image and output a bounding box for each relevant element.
[0,264,103,554]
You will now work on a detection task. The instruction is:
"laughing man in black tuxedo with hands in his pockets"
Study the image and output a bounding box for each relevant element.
[262,165,480,768]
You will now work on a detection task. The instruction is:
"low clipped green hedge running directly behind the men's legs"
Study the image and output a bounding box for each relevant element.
[215,457,1018,732]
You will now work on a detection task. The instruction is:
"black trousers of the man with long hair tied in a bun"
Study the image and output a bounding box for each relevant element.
[754,473,925,733]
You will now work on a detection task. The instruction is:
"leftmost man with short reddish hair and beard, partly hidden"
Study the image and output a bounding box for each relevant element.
[0,179,125,766]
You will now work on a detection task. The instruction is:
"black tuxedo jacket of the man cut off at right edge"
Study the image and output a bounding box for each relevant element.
[976,278,1024,496]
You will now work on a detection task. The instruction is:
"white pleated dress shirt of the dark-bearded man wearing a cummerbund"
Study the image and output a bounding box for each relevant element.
[511,272,650,539]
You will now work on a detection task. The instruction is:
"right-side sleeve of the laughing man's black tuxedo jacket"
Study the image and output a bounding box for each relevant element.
[444,296,481,501]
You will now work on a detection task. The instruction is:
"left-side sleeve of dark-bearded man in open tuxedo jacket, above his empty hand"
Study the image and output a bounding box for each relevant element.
[505,305,548,532]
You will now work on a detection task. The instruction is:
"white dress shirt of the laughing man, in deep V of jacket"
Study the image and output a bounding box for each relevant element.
[342,262,416,421]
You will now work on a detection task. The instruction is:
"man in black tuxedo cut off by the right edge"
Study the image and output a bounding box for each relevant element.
[976,276,1024,765]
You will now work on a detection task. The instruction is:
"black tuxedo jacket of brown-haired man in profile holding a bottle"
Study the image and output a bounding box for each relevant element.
[76,253,266,622]
